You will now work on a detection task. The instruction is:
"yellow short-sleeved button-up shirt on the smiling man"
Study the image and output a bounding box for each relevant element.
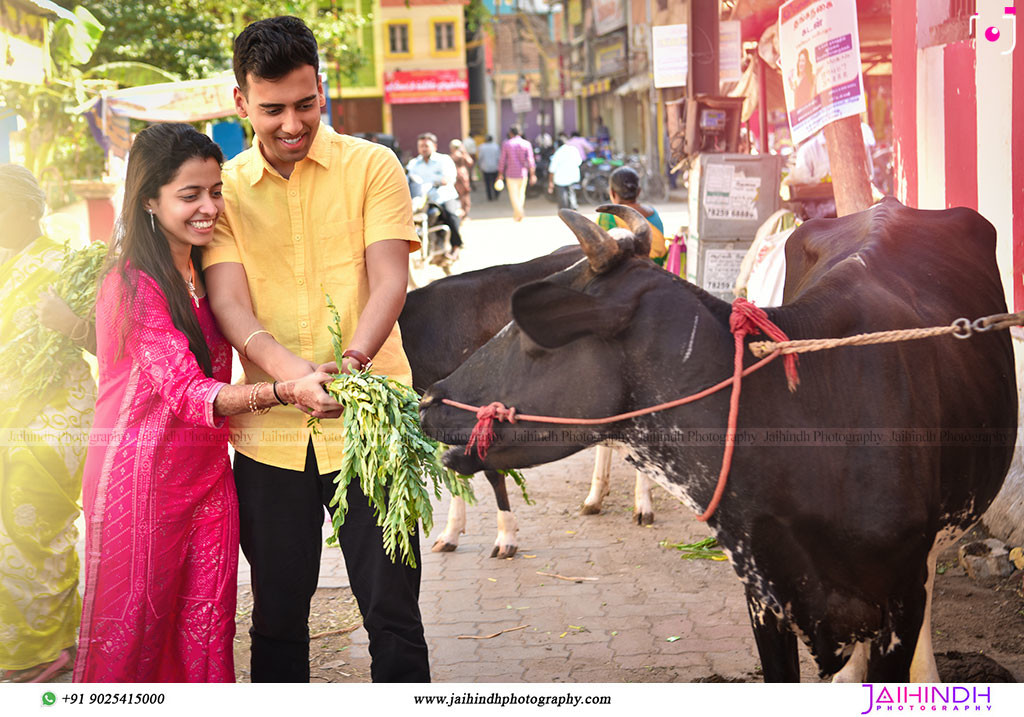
[203,125,419,473]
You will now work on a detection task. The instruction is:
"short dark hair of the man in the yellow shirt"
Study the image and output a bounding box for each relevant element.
[231,15,319,94]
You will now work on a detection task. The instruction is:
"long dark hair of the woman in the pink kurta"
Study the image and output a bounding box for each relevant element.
[108,124,224,376]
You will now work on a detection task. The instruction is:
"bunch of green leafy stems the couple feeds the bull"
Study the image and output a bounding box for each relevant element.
[311,296,473,567]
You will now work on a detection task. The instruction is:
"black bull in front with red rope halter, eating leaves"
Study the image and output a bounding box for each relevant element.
[421,199,1017,680]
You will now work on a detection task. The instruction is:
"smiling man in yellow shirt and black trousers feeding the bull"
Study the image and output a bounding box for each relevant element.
[204,17,430,682]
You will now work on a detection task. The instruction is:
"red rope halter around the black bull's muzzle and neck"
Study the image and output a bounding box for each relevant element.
[441,298,800,520]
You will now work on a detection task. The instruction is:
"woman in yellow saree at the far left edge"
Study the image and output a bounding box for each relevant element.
[0,165,96,682]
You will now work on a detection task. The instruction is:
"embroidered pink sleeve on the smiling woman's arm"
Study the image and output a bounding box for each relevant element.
[125,275,226,428]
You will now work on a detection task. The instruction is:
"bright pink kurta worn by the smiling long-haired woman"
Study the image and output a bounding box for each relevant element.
[75,269,239,682]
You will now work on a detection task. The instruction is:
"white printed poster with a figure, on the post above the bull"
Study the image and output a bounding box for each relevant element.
[778,0,866,142]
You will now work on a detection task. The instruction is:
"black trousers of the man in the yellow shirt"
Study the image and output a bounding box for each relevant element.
[234,442,430,682]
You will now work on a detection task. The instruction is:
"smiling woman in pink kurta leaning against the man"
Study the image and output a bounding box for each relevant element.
[75,124,329,682]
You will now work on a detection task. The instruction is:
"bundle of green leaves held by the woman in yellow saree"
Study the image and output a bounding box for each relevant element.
[0,242,106,397]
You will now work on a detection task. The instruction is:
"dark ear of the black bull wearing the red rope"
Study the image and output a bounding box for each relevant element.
[512,282,633,348]
